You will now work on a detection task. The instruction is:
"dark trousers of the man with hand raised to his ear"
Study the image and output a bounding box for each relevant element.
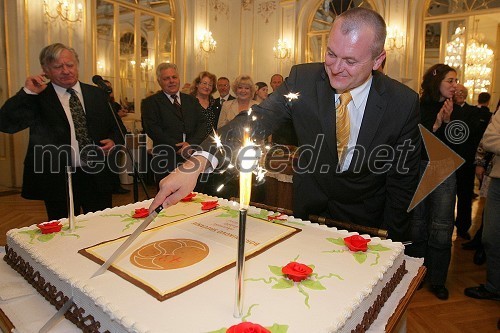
[44,168,112,221]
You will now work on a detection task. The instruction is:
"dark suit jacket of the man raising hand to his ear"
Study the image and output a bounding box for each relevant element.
[0,83,119,200]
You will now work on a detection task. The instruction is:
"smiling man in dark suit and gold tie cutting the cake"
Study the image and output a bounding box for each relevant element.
[150,8,420,240]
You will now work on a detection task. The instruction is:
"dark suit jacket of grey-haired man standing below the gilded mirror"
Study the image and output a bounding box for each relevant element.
[141,91,206,175]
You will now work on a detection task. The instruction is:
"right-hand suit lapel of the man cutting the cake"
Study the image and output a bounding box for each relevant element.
[356,73,387,147]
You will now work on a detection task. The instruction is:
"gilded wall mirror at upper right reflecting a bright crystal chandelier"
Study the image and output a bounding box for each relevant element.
[423,0,500,104]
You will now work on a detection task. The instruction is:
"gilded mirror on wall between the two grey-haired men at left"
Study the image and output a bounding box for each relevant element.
[95,0,175,120]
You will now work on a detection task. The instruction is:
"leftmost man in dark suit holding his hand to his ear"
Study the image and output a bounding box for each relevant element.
[0,43,118,220]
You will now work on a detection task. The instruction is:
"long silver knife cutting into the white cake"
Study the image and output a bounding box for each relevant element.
[38,205,163,333]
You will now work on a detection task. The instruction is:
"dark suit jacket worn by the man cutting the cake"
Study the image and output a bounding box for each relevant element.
[203,63,420,240]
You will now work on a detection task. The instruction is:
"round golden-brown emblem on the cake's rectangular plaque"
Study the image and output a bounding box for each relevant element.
[130,239,209,270]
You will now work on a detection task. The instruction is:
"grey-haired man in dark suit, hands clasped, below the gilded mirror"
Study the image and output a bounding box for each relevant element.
[141,63,206,183]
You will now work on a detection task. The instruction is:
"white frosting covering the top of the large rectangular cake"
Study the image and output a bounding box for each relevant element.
[7,195,404,333]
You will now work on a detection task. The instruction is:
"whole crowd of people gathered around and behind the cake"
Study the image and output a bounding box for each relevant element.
[0,8,500,316]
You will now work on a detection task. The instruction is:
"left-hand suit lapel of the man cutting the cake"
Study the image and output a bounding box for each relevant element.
[316,73,337,159]
